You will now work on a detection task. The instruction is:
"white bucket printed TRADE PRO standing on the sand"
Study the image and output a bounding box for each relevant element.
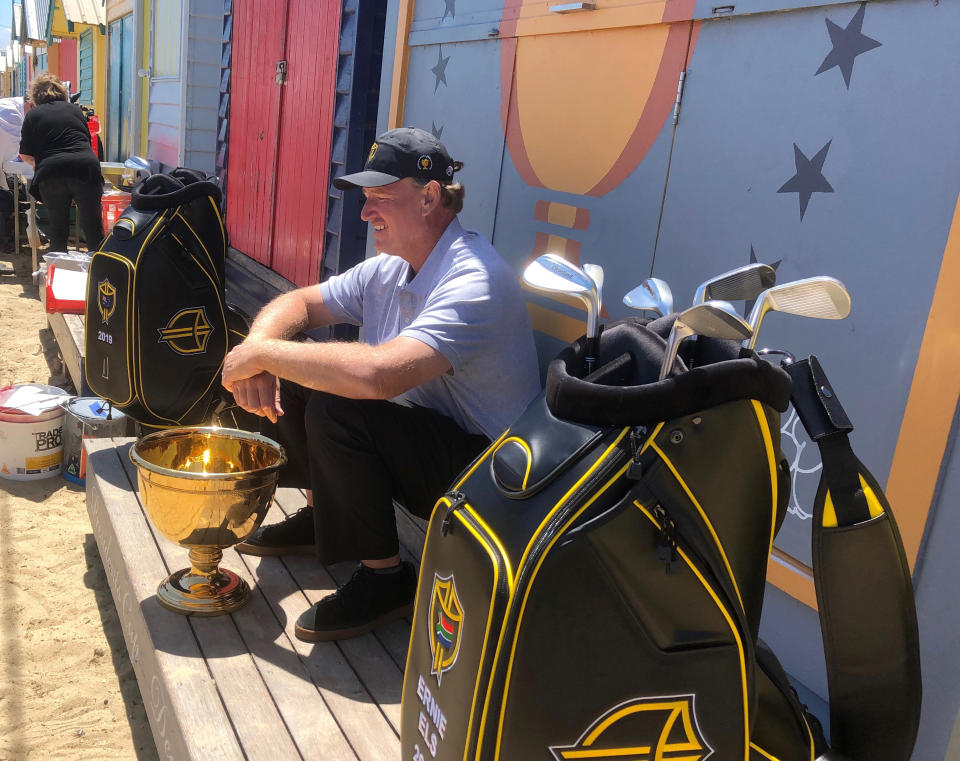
[0,383,70,481]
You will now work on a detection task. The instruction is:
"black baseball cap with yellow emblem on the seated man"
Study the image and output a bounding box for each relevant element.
[333,127,463,190]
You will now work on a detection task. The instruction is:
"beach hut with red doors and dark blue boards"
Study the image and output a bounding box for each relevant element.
[219,0,387,287]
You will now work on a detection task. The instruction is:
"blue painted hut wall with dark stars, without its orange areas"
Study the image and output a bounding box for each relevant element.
[380,0,960,761]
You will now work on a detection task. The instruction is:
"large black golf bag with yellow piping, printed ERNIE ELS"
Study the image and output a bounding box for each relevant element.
[402,318,920,761]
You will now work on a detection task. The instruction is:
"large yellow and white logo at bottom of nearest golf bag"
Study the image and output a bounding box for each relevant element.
[550,695,713,761]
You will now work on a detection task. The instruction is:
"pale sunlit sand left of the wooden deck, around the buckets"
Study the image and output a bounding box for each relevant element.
[0,247,157,761]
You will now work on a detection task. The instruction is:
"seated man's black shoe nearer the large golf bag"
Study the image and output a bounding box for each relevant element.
[294,562,417,642]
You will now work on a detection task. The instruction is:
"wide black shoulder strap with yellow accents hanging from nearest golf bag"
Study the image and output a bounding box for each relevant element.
[785,356,922,761]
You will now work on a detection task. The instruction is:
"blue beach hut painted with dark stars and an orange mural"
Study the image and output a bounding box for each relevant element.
[379,0,960,760]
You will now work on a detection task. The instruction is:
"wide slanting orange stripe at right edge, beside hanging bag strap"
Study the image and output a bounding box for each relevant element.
[885,193,960,568]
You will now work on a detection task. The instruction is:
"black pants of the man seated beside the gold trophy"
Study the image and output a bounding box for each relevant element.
[260,381,490,563]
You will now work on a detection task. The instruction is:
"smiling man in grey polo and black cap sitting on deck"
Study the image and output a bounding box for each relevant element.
[223,127,540,641]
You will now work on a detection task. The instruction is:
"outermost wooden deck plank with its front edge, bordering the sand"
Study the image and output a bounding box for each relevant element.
[86,439,244,761]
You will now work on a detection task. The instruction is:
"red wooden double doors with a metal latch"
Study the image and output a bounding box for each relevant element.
[227,0,340,285]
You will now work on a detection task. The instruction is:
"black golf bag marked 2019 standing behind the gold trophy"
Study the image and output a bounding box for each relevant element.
[85,169,247,427]
